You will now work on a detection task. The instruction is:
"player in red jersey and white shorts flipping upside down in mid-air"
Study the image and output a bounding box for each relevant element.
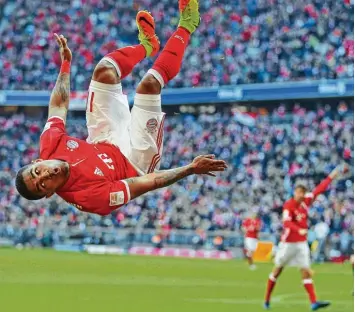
[16,0,227,215]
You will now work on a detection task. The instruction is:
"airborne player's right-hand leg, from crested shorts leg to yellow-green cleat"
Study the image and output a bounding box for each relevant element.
[128,0,200,174]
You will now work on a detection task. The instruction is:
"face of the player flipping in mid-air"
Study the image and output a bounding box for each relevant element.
[23,159,69,197]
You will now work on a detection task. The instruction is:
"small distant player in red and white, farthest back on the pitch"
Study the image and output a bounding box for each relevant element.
[242,215,261,270]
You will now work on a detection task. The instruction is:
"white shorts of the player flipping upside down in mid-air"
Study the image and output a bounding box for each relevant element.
[86,80,165,175]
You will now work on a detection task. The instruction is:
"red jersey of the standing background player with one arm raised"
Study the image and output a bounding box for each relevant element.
[281,177,332,243]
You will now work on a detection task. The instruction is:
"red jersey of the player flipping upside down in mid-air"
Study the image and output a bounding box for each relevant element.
[40,117,138,215]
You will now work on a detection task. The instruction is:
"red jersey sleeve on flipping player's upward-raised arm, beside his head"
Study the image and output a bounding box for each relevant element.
[39,117,66,159]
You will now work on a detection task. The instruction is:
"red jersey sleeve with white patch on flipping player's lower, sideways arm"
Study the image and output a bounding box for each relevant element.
[85,180,131,215]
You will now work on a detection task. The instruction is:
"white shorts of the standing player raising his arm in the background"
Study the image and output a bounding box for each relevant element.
[275,242,311,269]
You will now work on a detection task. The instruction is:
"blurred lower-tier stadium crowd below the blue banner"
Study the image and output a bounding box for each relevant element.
[0,102,354,255]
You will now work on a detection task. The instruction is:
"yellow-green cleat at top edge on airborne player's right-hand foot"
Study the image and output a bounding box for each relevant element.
[179,0,201,34]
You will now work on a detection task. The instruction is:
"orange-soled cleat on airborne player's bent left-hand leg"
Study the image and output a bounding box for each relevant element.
[136,11,160,56]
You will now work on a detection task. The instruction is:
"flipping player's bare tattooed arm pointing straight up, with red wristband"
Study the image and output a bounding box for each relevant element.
[48,34,72,122]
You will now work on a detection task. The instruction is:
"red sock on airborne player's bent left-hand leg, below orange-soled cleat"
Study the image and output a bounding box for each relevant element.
[105,44,146,79]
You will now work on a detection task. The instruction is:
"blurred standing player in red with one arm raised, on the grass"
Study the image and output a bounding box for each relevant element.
[264,166,348,311]
